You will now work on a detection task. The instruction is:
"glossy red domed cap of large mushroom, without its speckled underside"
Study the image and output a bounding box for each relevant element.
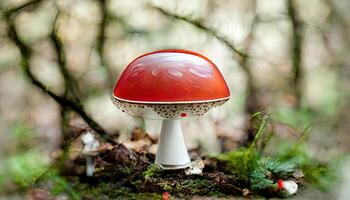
[114,50,230,103]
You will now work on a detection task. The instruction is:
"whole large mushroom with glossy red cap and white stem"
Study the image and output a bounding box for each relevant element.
[113,50,230,169]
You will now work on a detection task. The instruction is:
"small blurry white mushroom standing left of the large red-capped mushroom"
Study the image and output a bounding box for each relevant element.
[81,131,100,176]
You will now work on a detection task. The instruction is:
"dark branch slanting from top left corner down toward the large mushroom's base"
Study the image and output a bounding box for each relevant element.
[5,1,115,143]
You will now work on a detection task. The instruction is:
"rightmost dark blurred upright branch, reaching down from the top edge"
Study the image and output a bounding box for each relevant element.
[287,0,303,107]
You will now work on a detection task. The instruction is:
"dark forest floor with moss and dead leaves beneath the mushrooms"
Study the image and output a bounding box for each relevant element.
[16,115,336,200]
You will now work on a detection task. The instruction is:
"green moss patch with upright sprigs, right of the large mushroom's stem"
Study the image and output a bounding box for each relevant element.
[216,113,336,191]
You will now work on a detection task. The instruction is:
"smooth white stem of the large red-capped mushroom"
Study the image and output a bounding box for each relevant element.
[155,119,190,169]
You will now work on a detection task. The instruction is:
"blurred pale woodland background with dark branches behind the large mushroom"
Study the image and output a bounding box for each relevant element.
[0,0,350,199]
